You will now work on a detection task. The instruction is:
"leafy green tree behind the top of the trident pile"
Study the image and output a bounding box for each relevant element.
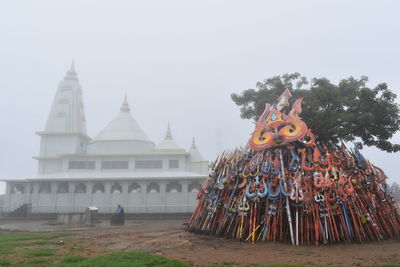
[231,73,400,152]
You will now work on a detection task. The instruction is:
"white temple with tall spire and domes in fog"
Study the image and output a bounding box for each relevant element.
[4,64,208,216]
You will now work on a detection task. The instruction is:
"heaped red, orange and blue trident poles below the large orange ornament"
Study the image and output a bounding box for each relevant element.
[187,146,400,245]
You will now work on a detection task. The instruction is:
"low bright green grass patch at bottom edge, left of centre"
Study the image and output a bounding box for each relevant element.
[55,252,188,267]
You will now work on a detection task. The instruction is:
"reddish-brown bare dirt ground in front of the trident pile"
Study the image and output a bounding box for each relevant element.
[2,219,400,266]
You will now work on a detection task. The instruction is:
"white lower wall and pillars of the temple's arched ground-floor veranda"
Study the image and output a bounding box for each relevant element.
[4,179,204,213]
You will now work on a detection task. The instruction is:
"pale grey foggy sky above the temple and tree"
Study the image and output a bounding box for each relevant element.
[0,0,400,195]
